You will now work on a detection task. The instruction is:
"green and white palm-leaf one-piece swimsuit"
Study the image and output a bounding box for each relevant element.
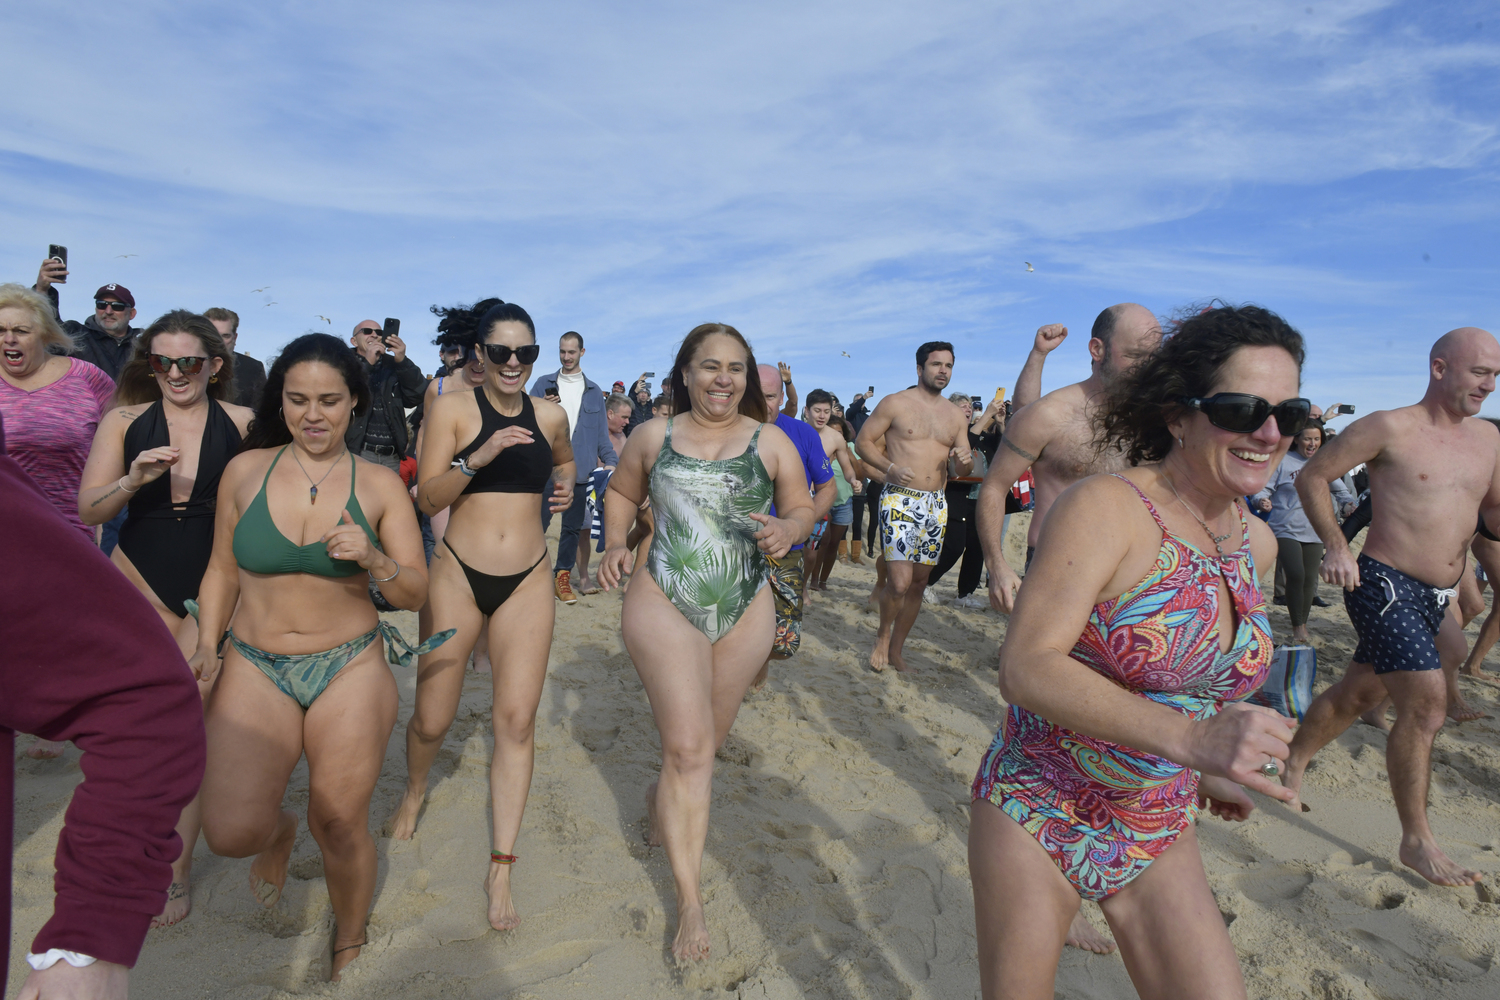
[647,417,774,643]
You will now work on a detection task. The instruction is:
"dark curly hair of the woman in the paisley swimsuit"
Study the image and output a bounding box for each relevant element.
[1100,303,1305,465]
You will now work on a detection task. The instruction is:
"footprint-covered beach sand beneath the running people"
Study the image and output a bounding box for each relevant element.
[11,519,1500,1000]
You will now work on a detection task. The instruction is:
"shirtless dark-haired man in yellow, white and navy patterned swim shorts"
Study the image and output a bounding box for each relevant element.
[855,340,974,670]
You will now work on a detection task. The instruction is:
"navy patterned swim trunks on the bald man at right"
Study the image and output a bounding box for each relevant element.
[1344,555,1457,673]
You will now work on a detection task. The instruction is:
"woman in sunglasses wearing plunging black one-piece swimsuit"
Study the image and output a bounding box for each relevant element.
[78,310,255,927]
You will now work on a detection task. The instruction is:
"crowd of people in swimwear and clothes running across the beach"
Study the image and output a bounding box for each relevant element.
[0,244,1500,997]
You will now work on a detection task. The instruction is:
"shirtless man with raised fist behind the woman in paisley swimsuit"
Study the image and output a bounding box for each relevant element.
[978,303,1161,613]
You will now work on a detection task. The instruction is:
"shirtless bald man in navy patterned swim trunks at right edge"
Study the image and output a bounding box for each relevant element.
[1283,327,1500,886]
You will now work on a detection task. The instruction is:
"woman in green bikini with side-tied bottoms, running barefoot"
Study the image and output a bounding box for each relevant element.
[189,333,447,981]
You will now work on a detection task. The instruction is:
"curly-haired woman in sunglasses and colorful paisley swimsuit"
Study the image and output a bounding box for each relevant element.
[969,306,1308,999]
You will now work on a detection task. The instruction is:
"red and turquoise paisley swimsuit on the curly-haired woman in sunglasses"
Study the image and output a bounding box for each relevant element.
[972,475,1271,900]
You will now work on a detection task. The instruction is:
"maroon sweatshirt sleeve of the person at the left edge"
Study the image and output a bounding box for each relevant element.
[0,413,204,994]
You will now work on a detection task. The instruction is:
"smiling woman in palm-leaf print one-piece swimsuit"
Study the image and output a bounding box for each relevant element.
[599,324,813,961]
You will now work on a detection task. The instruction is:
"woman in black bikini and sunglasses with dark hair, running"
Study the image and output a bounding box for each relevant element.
[390,303,575,931]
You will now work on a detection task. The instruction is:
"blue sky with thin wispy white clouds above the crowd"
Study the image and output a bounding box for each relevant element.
[0,0,1500,414]
